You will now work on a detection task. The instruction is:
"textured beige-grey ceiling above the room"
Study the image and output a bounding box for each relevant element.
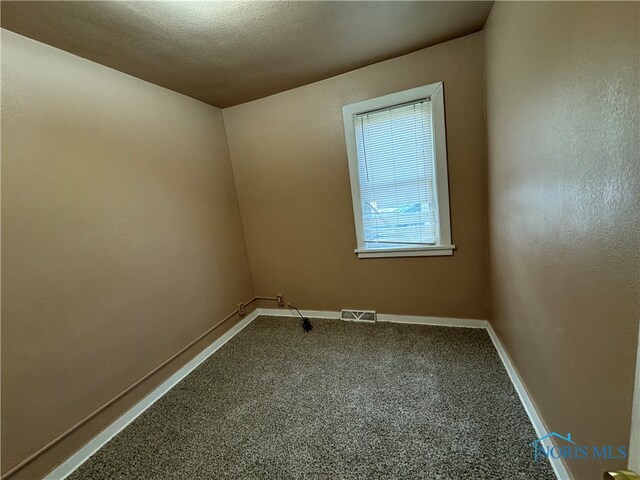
[0,1,492,107]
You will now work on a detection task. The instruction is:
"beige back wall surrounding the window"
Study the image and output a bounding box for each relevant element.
[224,33,488,318]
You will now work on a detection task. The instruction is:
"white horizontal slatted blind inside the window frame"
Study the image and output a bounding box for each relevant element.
[354,98,438,249]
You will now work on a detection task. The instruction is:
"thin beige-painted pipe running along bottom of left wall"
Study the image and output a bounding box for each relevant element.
[0,297,277,480]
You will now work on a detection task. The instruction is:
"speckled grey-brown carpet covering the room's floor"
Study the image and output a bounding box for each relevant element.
[69,317,554,480]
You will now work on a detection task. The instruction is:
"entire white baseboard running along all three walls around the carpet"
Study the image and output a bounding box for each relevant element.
[45,308,572,480]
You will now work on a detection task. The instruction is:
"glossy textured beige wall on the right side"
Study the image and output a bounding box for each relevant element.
[485,2,640,479]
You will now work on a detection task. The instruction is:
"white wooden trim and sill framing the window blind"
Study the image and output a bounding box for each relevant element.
[342,82,456,258]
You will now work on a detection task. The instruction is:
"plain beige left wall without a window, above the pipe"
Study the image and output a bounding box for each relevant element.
[2,30,253,478]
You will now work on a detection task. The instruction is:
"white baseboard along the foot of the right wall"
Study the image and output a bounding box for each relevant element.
[487,322,573,480]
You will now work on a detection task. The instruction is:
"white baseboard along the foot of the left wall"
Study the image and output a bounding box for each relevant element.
[45,310,259,480]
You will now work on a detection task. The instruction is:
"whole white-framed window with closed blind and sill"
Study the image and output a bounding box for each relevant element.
[342,82,455,258]
